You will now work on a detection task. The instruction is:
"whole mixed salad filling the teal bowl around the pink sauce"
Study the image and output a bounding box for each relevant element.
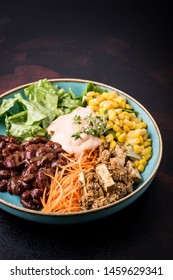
[0,79,152,212]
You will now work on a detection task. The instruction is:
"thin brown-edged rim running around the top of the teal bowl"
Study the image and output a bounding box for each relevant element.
[0,78,163,218]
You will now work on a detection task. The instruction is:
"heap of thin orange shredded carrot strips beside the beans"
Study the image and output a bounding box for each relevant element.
[41,149,98,213]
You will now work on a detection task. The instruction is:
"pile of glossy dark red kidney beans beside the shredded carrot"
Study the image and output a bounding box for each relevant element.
[0,135,67,210]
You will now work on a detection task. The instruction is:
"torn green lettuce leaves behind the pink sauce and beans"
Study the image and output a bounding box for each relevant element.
[0,79,103,141]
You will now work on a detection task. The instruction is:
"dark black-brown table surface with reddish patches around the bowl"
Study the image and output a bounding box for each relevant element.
[0,0,173,260]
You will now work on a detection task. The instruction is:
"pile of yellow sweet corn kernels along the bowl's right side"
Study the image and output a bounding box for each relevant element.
[86,91,152,172]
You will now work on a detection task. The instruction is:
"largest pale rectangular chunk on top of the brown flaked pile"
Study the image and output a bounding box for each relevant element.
[96,163,115,192]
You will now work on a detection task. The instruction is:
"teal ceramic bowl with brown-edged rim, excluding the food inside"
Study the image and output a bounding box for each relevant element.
[0,79,162,224]
